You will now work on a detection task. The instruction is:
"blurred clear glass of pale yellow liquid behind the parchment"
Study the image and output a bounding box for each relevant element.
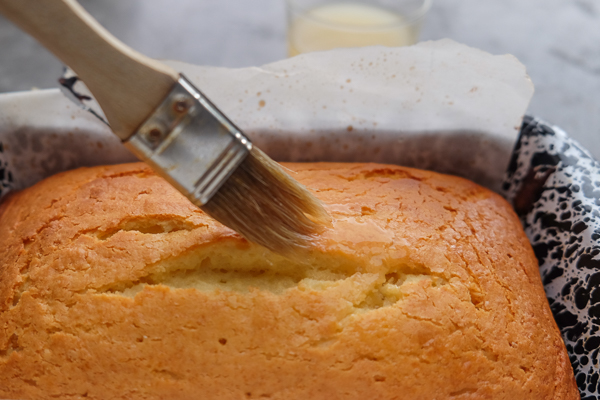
[288,3,419,57]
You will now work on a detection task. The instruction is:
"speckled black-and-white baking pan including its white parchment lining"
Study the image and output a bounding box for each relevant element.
[0,40,600,399]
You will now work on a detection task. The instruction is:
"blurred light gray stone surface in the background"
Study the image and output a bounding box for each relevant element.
[0,0,600,158]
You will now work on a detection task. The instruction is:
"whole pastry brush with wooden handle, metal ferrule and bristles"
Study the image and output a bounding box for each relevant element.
[0,0,328,253]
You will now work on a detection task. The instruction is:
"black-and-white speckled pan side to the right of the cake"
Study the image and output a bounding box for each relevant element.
[503,117,600,400]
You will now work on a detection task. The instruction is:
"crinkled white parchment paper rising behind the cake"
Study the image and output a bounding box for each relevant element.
[0,40,533,194]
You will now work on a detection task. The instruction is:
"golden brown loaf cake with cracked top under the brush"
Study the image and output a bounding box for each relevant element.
[0,164,579,400]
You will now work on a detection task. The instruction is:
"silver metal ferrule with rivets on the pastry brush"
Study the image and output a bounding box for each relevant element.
[125,75,252,206]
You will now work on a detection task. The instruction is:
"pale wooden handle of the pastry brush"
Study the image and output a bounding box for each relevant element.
[0,0,178,139]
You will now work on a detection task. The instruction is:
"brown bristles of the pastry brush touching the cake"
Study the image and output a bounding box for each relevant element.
[202,147,330,254]
